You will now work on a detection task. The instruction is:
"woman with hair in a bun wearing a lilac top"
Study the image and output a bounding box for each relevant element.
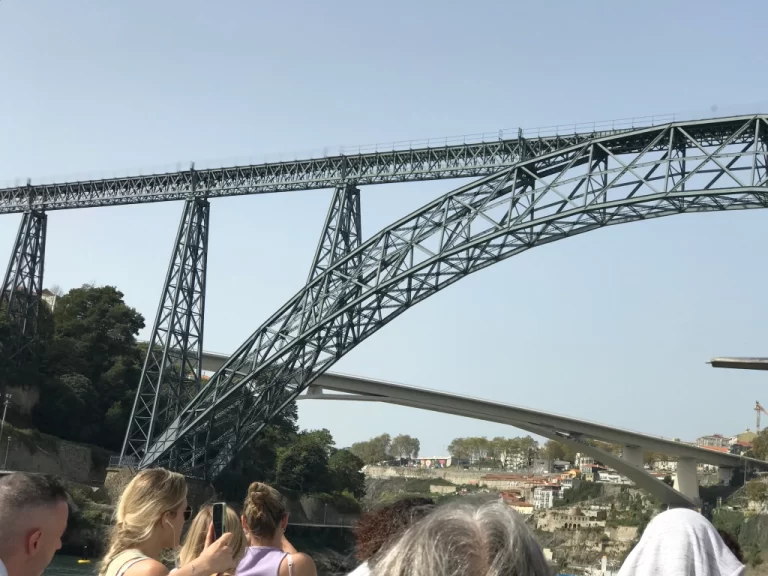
[237,482,317,576]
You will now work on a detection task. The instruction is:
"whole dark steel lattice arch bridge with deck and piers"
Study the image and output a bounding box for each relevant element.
[0,115,768,478]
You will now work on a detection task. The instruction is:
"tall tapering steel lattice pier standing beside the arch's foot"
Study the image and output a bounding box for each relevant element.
[120,197,210,466]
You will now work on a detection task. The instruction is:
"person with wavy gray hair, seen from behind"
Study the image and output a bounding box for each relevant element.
[371,502,552,576]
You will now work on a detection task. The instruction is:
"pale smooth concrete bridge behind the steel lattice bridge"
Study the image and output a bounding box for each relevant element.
[202,352,768,506]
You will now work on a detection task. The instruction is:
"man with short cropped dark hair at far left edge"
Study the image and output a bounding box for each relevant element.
[0,472,69,576]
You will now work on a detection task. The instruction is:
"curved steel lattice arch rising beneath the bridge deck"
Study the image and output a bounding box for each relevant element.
[141,116,768,478]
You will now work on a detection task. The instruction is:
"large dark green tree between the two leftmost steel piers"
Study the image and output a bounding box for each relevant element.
[33,285,144,450]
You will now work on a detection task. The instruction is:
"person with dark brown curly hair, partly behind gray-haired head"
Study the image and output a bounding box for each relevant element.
[349,498,435,576]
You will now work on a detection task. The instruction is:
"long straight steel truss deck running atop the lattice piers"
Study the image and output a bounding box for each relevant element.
[0,130,626,214]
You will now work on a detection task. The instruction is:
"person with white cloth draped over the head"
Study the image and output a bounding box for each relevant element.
[619,508,745,576]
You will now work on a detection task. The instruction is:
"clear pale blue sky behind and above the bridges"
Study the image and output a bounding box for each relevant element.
[0,0,768,455]
